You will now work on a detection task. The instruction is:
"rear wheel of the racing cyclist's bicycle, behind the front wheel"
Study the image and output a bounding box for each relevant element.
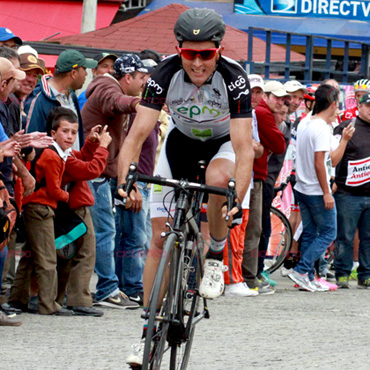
[170,236,202,370]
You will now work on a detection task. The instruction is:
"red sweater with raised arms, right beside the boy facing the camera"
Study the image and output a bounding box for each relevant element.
[62,139,109,209]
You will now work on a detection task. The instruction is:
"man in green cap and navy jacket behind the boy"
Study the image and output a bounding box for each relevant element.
[25,49,98,150]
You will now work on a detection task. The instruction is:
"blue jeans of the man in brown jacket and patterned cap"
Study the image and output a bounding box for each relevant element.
[89,177,119,301]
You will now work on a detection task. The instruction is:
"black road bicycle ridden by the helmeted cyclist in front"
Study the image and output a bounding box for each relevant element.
[126,162,236,370]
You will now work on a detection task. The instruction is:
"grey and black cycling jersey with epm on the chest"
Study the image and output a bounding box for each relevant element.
[140,55,252,141]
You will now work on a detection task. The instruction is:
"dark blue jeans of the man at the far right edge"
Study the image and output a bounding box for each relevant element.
[334,192,370,280]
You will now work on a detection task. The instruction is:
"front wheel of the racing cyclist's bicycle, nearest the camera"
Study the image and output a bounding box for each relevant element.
[142,234,178,370]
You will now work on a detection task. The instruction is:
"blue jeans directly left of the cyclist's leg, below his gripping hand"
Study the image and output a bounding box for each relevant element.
[115,182,149,296]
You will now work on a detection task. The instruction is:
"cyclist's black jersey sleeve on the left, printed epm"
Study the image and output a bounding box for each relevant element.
[140,55,181,111]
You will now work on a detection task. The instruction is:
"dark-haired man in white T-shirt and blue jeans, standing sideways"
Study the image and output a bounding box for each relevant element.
[288,85,339,292]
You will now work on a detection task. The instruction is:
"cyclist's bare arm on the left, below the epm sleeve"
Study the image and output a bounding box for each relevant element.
[117,105,160,192]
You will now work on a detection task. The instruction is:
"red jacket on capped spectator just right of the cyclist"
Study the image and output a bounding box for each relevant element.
[253,99,286,181]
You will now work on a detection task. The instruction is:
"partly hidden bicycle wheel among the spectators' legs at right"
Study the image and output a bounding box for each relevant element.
[264,207,293,273]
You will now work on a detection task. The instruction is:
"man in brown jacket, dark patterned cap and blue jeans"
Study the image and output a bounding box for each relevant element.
[81,54,147,309]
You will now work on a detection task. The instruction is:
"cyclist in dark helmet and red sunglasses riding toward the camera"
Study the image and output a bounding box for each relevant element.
[118,9,254,365]
